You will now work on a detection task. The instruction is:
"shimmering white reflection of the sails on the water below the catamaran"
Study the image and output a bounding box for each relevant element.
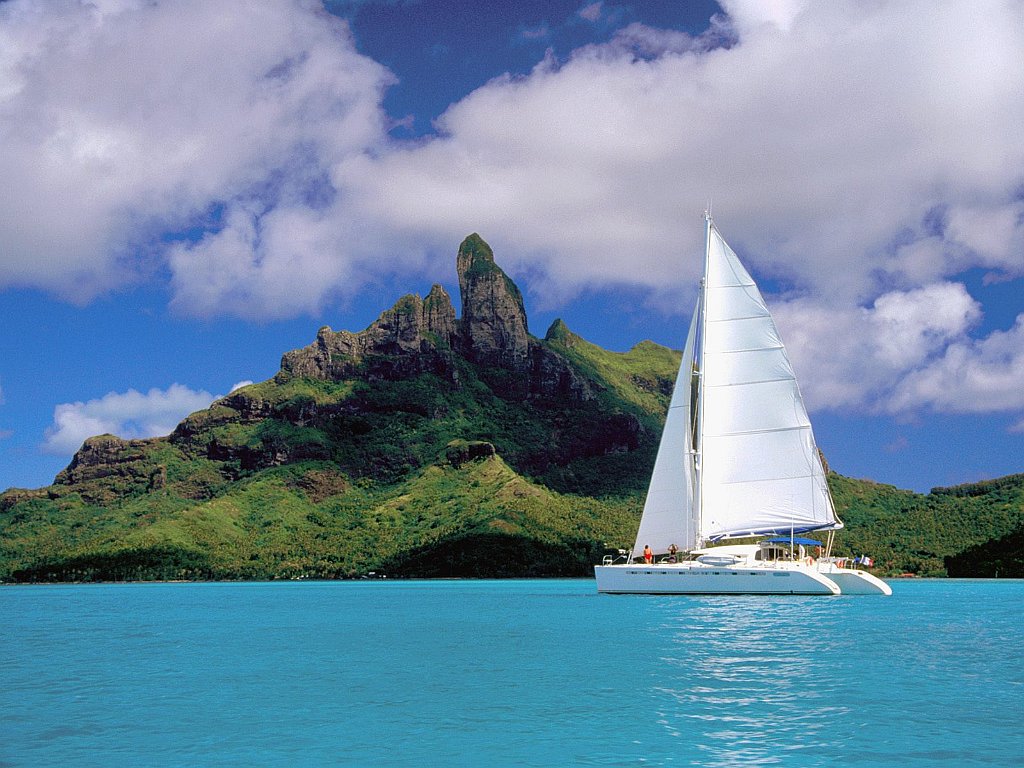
[652,596,850,766]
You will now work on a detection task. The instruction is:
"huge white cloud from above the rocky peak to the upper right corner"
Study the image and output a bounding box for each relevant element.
[334,2,1024,306]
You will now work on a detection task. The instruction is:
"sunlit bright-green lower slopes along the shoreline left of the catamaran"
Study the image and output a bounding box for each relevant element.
[0,448,637,581]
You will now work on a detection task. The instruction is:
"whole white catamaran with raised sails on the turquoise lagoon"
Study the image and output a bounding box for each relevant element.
[594,213,892,595]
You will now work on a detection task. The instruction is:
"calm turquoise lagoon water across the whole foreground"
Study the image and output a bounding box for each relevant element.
[0,581,1024,767]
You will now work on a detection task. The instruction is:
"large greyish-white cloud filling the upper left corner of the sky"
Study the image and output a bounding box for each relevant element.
[0,0,393,314]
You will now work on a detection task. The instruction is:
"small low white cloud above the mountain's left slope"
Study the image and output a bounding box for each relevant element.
[43,384,216,455]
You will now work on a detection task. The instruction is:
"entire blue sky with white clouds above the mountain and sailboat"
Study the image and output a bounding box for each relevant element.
[0,0,1024,490]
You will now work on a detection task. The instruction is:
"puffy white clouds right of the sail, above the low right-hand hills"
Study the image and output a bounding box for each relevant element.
[772,283,1024,431]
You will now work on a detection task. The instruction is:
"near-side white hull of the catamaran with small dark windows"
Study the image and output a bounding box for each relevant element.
[594,562,841,595]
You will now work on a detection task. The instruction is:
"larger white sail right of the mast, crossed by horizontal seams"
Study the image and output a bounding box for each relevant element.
[698,221,842,540]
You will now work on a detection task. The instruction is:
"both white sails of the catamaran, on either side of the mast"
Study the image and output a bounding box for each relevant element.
[634,217,842,555]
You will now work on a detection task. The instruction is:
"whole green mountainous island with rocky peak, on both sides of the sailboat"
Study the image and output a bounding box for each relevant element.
[0,234,1024,582]
